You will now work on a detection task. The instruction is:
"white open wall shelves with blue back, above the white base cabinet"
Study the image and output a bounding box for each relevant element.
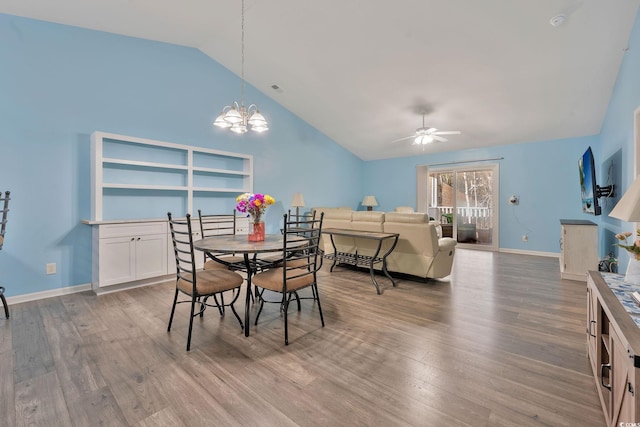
[91,132,253,221]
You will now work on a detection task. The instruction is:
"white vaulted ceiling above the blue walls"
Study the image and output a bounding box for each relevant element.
[0,0,640,160]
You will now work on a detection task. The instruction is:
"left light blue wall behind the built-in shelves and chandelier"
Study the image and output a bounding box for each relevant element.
[0,14,363,296]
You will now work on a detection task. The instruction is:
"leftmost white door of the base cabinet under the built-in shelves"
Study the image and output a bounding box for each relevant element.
[98,236,136,286]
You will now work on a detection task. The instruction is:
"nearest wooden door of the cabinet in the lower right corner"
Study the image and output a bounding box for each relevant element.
[610,329,638,426]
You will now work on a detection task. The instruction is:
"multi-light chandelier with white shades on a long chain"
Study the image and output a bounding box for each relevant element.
[213,0,269,134]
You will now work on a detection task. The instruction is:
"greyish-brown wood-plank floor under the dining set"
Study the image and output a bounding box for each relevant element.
[0,250,604,427]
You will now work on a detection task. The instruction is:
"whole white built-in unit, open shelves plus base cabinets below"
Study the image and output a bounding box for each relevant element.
[83,132,253,293]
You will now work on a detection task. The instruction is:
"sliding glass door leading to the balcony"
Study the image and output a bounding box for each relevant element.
[418,164,498,250]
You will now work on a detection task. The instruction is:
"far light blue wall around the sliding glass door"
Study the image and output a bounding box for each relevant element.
[364,137,598,253]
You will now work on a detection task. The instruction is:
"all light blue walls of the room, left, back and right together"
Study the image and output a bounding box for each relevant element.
[0,6,640,296]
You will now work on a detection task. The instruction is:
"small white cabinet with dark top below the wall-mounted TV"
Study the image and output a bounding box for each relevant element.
[560,219,600,282]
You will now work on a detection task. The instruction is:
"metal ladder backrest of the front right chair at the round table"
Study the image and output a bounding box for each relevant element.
[282,213,324,292]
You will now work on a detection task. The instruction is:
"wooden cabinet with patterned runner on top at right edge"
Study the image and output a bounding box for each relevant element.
[586,271,640,427]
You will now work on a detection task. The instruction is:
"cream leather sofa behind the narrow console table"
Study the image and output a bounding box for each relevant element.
[312,207,457,279]
